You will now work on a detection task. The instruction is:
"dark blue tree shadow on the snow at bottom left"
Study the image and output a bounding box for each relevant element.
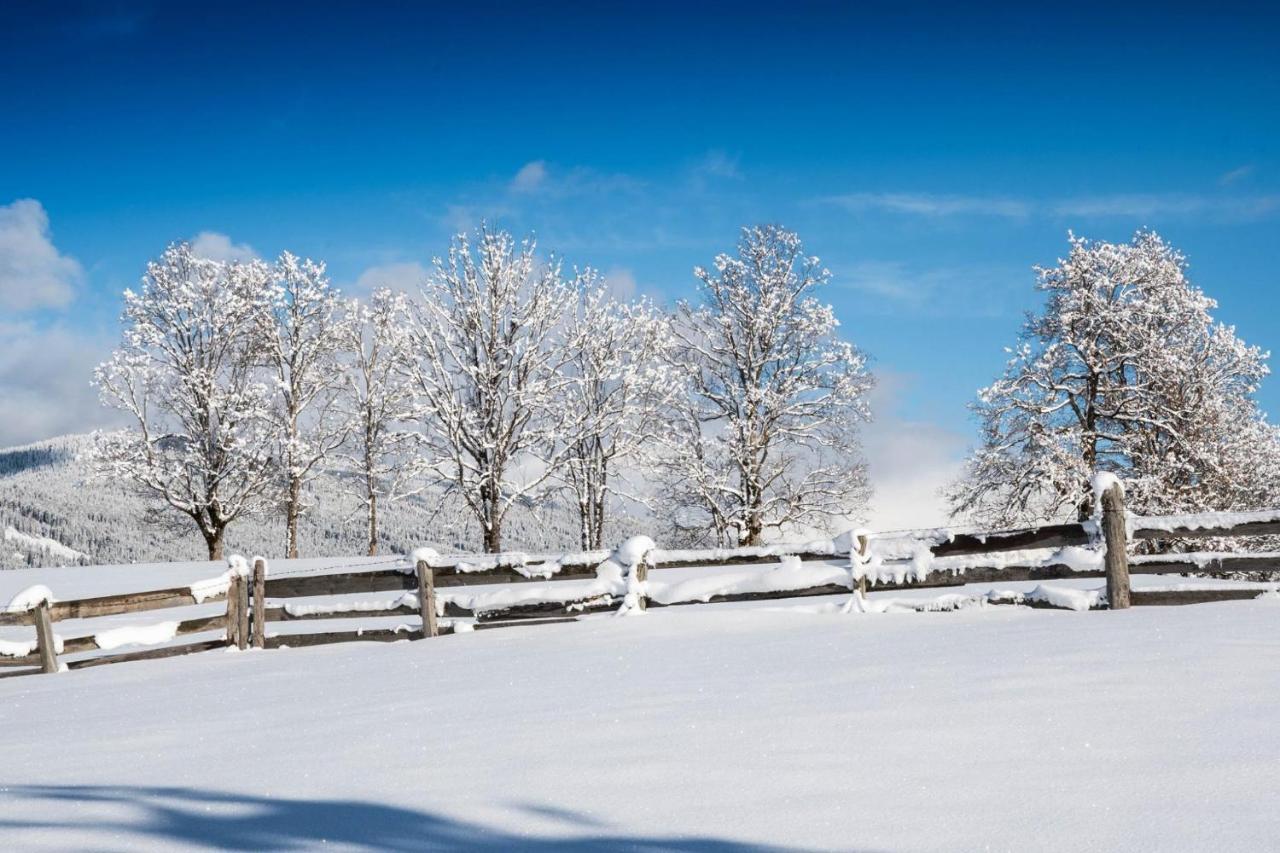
[0,785,860,853]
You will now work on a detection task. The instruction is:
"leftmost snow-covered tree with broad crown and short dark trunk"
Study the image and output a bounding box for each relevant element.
[95,243,276,560]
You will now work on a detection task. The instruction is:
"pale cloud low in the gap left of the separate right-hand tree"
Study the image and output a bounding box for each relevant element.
[863,371,969,530]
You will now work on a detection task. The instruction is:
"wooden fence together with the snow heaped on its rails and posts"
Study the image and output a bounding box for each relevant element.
[0,483,1280,675]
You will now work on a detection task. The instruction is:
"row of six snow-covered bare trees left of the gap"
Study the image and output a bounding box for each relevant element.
[96,225,872,560]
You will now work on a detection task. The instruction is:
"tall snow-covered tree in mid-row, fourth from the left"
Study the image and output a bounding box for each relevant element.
[413,228,573,552]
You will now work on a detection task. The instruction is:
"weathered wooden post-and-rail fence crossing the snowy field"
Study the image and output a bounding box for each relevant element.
[0,484,1280,676]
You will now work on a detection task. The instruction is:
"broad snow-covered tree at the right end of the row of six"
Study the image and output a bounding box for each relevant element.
[650,225,872,544]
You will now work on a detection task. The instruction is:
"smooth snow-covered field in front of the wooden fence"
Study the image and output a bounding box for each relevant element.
[0,584,1280,853]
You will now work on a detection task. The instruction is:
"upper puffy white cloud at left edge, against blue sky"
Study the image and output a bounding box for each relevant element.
[0,199,83,311]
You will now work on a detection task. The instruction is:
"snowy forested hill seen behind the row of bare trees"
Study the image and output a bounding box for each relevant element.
[0,435,643,569]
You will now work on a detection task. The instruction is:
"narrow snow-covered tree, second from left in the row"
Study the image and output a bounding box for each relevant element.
[257,252,347,558]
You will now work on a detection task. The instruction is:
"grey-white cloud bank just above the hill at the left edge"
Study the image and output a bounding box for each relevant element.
[0,324,122,447]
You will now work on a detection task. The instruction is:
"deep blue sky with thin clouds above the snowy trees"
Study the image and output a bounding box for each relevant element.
[0,3,1280,521]
